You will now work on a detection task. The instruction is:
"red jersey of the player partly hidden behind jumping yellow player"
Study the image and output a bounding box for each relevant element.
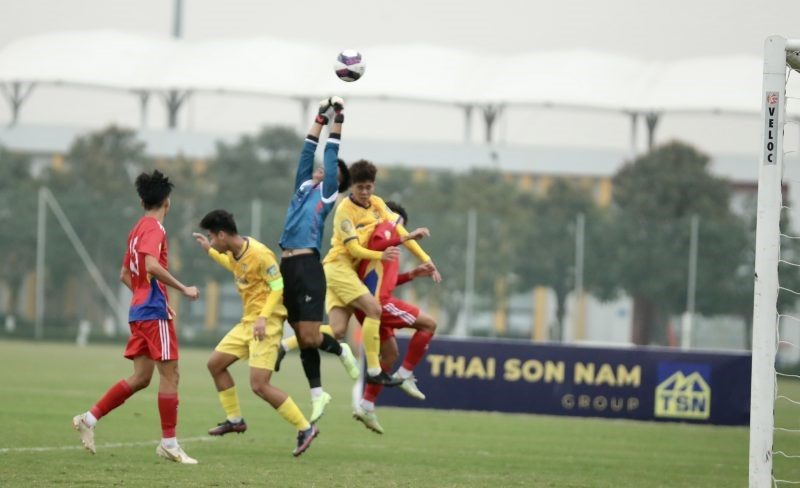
[358,220,410,303]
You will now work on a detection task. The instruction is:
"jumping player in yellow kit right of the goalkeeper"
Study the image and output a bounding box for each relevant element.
[323,160,442,386]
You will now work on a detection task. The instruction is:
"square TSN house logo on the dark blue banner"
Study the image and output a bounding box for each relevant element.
[655,362,711,420]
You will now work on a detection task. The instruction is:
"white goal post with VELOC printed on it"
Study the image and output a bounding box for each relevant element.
[749,36,800,488]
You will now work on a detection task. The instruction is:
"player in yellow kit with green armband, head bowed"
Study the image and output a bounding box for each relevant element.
[192,210,319,456]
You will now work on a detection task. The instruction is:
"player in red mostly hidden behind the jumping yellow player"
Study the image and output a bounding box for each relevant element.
[353,202,436,434]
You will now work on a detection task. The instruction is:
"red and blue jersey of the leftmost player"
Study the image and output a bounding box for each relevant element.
[122,216,170,322]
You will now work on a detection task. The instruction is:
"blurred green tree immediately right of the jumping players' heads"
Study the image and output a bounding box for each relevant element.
[376,169,518,333]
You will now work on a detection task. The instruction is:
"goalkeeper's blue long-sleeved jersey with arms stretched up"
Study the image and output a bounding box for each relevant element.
[280,137,339,253]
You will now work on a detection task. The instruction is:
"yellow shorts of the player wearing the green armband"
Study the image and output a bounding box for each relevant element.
[215,314,286,371]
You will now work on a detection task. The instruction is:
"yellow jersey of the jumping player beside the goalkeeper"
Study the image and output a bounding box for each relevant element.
[322,195,399,267]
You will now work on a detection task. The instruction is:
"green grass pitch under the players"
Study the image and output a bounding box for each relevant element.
[0,341,800,488]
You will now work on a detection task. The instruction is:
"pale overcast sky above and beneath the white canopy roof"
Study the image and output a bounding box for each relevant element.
[0,0,800,154]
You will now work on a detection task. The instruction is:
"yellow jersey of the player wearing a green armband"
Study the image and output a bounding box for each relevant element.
[208,237,286,322]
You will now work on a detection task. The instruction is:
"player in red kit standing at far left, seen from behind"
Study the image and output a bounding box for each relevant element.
[72,171,200,464]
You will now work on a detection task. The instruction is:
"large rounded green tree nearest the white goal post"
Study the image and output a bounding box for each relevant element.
[613,142,747,344]
